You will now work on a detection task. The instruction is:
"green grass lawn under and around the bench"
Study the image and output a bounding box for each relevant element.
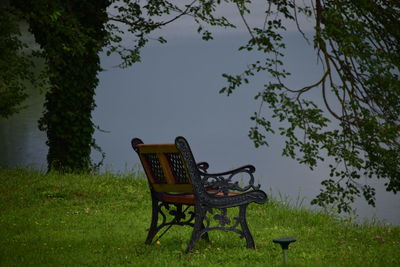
[0,168,400,266]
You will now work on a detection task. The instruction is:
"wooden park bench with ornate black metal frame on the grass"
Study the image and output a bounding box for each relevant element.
[131,137,267,252]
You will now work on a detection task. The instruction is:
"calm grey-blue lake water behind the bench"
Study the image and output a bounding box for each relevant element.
[0,31,400,225]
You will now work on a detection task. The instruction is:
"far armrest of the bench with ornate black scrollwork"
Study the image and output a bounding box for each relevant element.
[199,164,260,195]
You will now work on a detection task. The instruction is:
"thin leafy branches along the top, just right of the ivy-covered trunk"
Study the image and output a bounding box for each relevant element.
[106,0,238,67]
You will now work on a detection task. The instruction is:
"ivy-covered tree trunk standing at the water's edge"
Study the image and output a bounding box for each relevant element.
[15,0,110,172]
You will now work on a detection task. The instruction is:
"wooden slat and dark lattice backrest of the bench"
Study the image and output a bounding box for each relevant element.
[132,138,193,193]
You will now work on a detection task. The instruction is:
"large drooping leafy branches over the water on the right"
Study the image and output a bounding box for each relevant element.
[221,1,400,214]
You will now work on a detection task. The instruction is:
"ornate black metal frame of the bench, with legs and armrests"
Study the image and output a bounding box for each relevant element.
[132,137,267,252]
